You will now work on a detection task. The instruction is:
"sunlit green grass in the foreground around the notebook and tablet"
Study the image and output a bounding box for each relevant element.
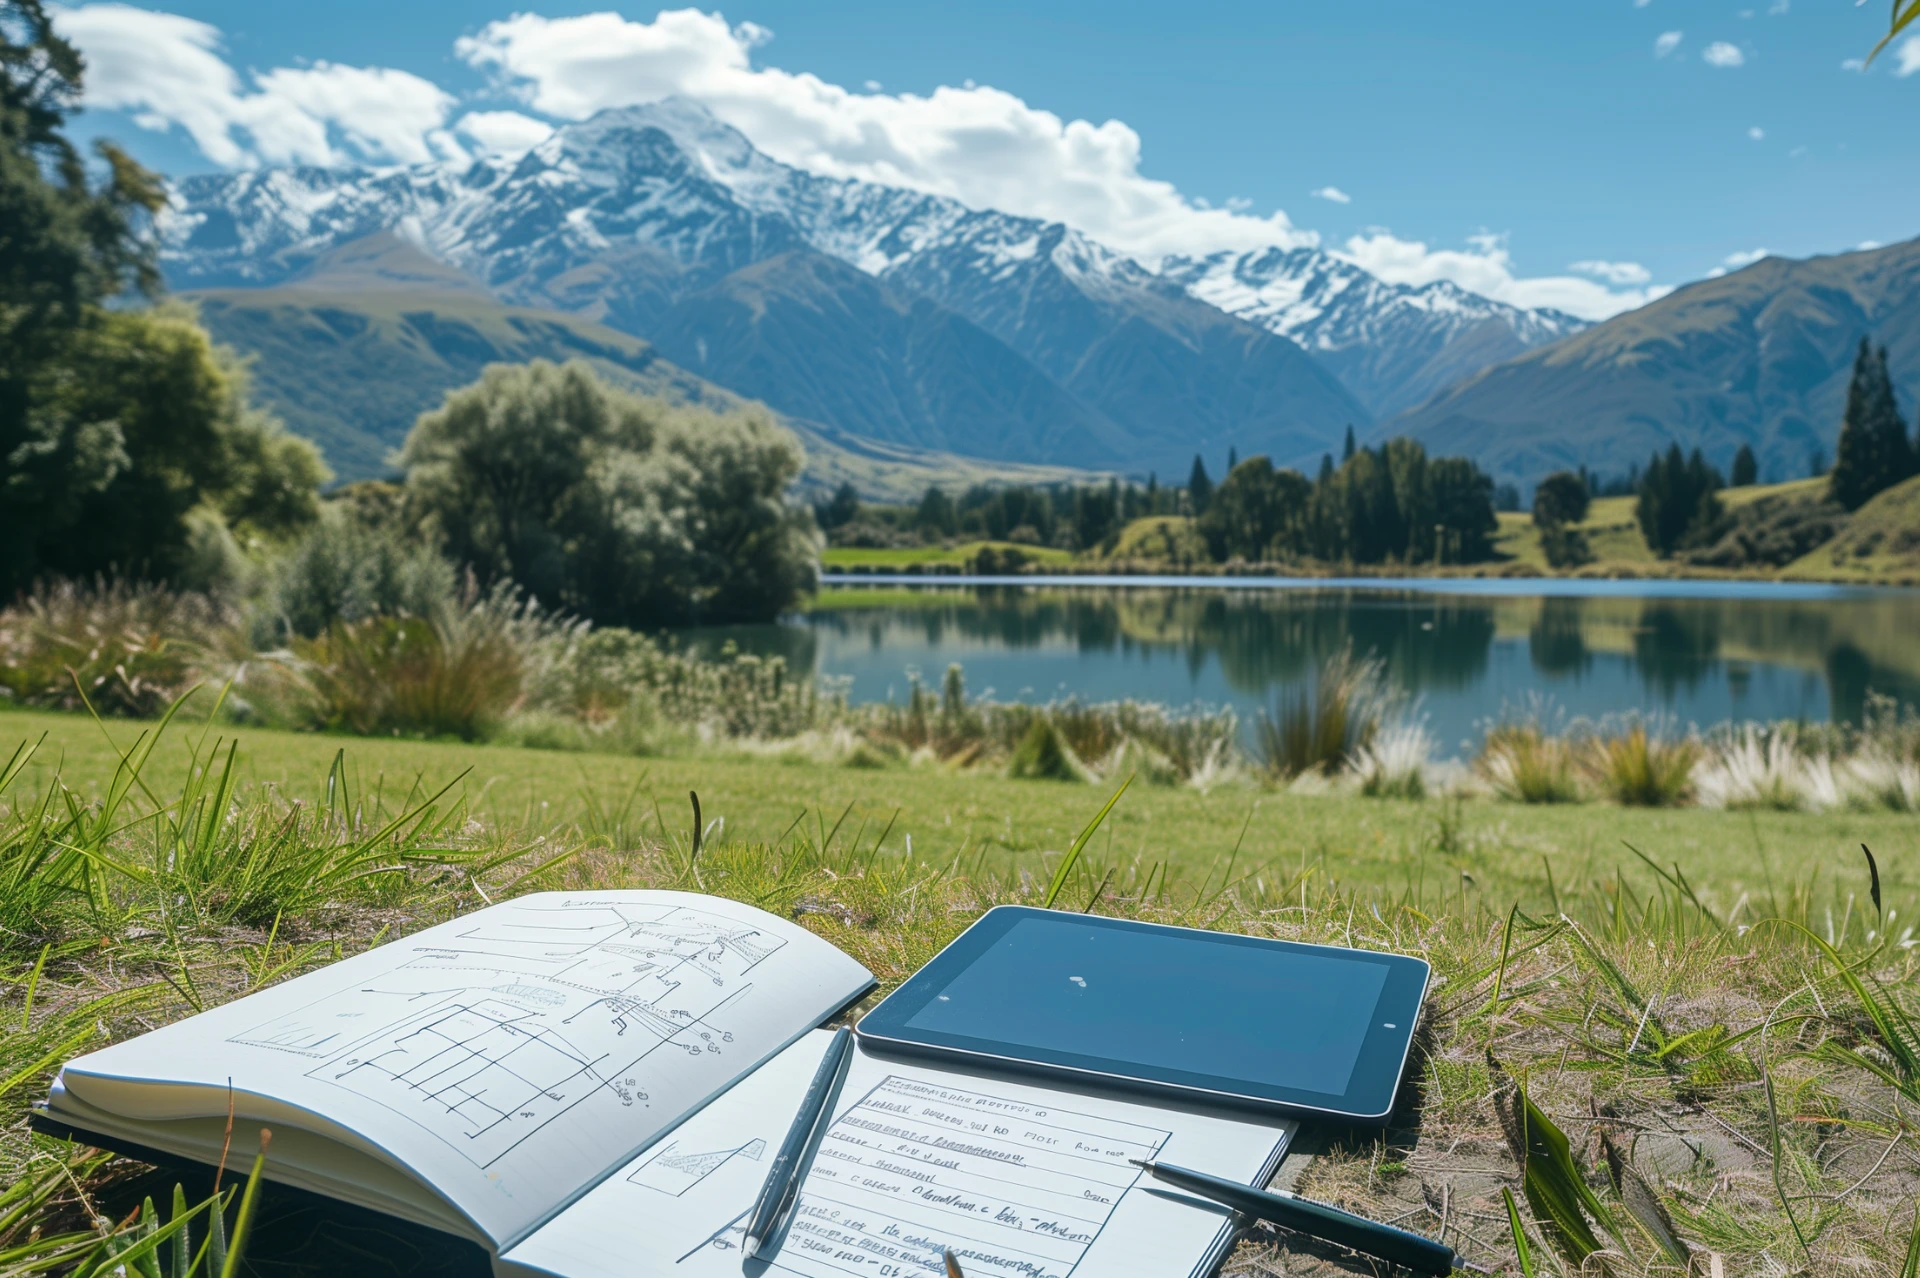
[0,712,1920,1278]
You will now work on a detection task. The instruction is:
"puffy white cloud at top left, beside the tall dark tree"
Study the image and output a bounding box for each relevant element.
[54,4,453,167]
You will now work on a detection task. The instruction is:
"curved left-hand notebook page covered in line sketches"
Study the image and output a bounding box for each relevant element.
[61,892,872,1245]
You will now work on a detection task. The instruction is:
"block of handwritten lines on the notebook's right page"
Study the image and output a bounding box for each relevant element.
[778,1075,1169,1278]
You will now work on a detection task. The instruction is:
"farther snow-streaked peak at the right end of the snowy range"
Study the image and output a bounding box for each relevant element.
[1160,248,1588,420]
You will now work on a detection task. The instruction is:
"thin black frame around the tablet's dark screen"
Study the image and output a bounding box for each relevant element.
[854,906,1432,1124]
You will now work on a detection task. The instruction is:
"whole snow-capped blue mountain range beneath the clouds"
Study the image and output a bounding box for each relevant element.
[163,100,1571,474]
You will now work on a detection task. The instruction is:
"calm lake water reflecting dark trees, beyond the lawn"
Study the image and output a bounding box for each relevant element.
[685,578,1920,750]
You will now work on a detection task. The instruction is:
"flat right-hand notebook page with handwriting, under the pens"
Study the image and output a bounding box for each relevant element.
[499,1032,1294,1278]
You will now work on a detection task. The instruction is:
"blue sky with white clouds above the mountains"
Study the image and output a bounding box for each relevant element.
[63,0,1920,315]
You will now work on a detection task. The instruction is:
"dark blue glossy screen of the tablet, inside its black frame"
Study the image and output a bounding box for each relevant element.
[906,919,1386,1096]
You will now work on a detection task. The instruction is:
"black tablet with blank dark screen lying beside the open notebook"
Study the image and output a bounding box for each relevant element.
[856,906,1430,1123]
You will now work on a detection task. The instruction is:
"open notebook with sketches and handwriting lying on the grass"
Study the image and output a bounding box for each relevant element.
[46,892,1292,1278]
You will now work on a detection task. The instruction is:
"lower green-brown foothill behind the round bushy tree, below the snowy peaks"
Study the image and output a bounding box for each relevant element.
[186,232,1113,501]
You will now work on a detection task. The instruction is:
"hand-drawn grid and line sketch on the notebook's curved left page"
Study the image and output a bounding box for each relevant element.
[228,898,785,1167]
